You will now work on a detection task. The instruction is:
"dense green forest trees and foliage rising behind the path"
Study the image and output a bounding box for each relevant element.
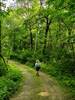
[0,0,75,72]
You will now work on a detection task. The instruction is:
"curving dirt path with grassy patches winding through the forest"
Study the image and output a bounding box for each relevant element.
[9,61,66,100]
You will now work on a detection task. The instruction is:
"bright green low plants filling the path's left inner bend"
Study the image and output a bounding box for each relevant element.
[0,65,22,100]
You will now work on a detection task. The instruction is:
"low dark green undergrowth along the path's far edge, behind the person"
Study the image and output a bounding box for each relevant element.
[10,49,46,66]
